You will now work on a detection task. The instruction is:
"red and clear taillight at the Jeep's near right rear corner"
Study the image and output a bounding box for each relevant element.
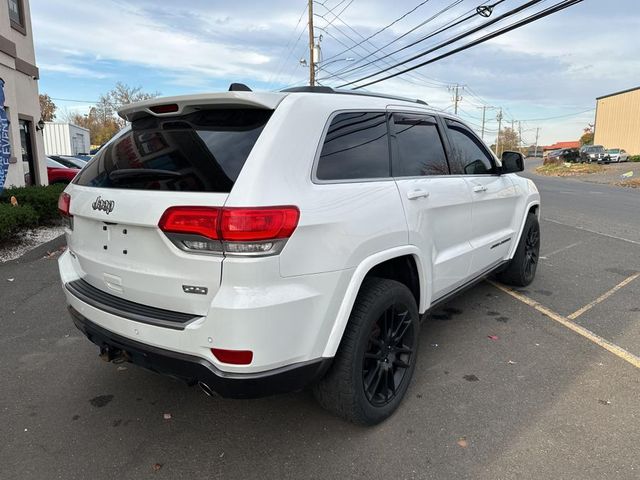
[158,206,300,256]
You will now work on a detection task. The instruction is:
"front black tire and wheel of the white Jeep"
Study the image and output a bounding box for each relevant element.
[496,213,540,287]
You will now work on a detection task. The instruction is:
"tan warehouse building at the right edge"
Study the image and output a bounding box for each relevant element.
[593,87,640,155]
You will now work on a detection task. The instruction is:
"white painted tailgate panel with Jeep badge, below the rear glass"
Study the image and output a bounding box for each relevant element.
[68,186,227,315]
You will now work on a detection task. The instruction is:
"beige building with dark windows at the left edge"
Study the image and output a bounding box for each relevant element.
[0,0,48,186]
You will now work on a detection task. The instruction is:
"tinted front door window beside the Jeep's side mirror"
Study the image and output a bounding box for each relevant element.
[447,120,493,175]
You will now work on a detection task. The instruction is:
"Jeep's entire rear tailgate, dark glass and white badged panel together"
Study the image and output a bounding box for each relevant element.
[66,102,280,315]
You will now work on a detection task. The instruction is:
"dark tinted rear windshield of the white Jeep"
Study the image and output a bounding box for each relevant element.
[74,109,273,193]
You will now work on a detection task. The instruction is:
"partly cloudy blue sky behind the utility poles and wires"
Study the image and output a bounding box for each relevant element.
[31,0,640,143]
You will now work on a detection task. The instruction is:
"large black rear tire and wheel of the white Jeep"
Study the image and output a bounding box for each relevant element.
[314,278,420,425]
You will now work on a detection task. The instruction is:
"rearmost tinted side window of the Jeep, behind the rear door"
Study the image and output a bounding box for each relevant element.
[316,112,390,180]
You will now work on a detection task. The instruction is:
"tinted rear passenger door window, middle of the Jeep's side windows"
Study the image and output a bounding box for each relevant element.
[393,113,449,177]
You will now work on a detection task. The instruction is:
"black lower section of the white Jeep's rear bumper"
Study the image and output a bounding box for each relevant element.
[69,307,332,398]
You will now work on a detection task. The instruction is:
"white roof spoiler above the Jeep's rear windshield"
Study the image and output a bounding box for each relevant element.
[118,91,287,122]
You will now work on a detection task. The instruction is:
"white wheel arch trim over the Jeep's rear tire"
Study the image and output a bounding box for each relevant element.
[322,245,430,357]
